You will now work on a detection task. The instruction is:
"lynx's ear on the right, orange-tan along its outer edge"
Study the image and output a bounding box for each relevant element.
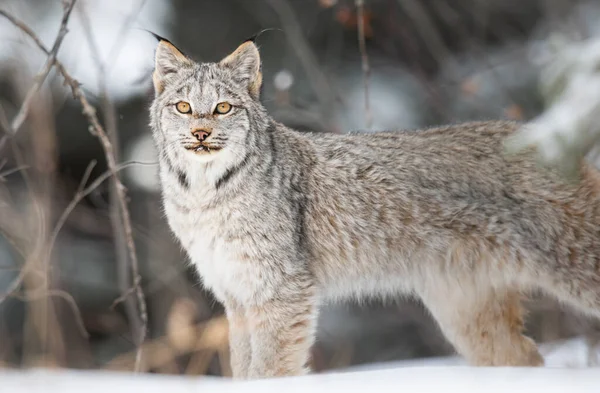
[220,40,262,99]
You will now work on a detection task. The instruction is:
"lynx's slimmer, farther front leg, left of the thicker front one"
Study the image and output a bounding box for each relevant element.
[225,302,252,379]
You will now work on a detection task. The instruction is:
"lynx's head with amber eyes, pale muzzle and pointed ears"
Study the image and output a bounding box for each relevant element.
[151,40,267,162]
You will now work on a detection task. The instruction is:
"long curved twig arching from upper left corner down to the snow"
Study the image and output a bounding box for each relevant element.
[2,11,148,369]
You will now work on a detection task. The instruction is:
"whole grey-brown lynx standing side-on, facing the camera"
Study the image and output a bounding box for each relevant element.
[151,40,600,379]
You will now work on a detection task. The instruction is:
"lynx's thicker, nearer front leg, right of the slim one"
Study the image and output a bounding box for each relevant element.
[248,287,317,378]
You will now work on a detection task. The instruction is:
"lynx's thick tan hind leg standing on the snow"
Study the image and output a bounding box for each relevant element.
[422,281,544,366]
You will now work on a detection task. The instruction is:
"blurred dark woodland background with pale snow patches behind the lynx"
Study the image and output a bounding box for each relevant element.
[0,0,600,375]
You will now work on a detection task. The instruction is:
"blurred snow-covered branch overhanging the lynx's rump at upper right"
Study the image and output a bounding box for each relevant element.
[508,2,600,175]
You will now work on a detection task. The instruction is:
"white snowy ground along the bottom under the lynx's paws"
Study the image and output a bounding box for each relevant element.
[0,340,600,393]
